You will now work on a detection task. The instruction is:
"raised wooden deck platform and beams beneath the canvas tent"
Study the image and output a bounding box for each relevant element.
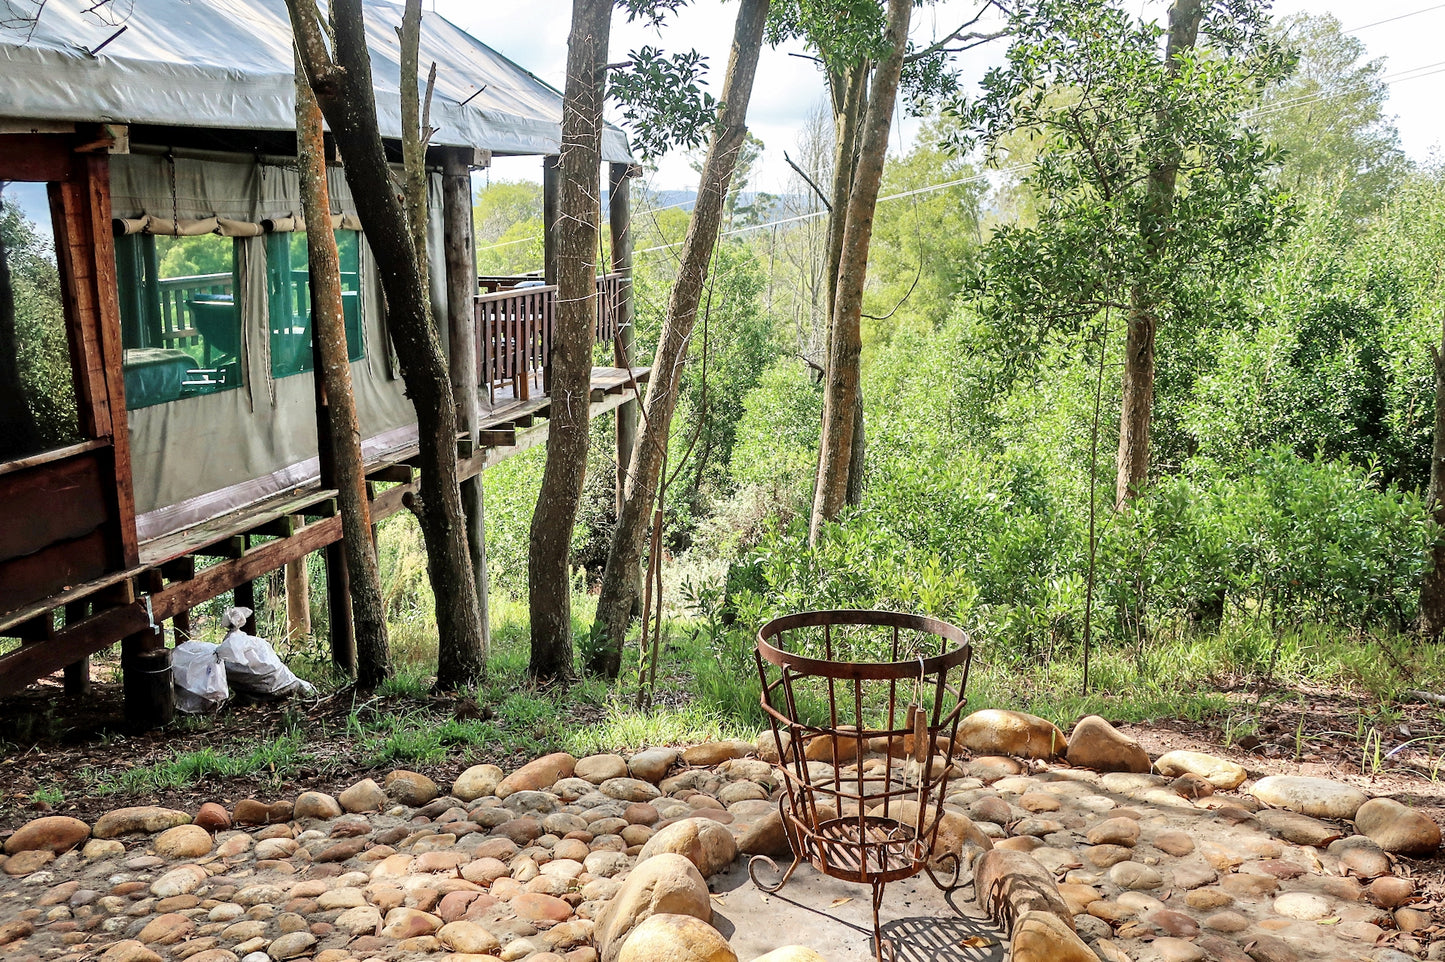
[0,367,650,696]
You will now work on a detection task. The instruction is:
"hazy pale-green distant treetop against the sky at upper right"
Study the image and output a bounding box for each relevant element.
[1254,13,1409,221]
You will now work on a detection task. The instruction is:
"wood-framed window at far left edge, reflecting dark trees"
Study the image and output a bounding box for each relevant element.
[0,181,81,461]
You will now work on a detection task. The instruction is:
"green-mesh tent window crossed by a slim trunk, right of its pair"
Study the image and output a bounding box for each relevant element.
[266,230,366,377]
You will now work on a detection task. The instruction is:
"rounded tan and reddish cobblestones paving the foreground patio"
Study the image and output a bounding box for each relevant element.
[0,711,1445,962]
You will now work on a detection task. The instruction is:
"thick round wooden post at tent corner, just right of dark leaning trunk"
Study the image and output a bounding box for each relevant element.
[442,150,494,660]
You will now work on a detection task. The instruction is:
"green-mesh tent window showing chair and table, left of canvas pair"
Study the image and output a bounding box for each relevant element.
[116,234,241,410]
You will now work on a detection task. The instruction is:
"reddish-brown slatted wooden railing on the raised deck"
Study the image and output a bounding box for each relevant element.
[475,274,623,400]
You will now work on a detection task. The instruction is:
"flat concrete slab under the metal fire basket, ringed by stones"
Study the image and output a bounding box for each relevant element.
[708,859,1007,962]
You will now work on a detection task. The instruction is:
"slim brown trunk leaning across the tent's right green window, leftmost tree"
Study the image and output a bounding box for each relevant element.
[296,59,392,689]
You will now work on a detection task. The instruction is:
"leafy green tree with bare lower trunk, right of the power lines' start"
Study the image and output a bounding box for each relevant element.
[965,0,1289,504]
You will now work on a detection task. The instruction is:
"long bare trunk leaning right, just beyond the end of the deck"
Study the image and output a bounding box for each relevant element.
[588,0,769,677]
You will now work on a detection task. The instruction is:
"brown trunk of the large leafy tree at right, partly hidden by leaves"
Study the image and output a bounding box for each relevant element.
[1114,0,1204,508]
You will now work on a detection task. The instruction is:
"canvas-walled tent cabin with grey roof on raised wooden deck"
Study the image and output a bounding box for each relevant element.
[0,0,647,716]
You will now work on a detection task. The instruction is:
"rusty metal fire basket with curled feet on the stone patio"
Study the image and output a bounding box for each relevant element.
[749,611,972,962]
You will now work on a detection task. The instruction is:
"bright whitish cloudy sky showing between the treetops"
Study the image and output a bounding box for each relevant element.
[428,0,1445,194]
